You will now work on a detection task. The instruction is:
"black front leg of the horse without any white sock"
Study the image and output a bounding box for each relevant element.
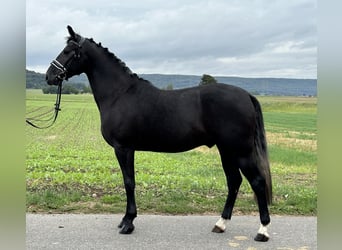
[115,148,137,234]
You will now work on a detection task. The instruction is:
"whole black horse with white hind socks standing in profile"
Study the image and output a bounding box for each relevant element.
[46,26,272,241]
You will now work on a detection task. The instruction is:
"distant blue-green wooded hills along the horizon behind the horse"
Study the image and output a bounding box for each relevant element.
[26,70,317,96]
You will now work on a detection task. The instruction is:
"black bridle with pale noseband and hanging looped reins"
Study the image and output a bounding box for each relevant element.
[26,37,85,129]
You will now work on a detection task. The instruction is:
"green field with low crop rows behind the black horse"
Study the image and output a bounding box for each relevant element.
[26,90,317,215]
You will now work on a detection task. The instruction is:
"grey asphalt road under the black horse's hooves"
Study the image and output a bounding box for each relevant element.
[26,214,317,250]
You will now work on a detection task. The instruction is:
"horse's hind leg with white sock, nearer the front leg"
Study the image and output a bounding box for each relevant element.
[212,150,242,233]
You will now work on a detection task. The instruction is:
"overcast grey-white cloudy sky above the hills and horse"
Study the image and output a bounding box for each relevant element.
[26,0,317,79]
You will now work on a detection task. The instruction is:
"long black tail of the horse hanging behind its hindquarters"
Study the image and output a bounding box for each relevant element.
[250,95,272,204]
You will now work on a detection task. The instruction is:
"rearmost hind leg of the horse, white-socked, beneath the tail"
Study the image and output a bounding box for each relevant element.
[239,157,271,241]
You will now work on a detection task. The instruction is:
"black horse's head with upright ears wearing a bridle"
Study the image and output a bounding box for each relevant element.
[46,26,86,85]
